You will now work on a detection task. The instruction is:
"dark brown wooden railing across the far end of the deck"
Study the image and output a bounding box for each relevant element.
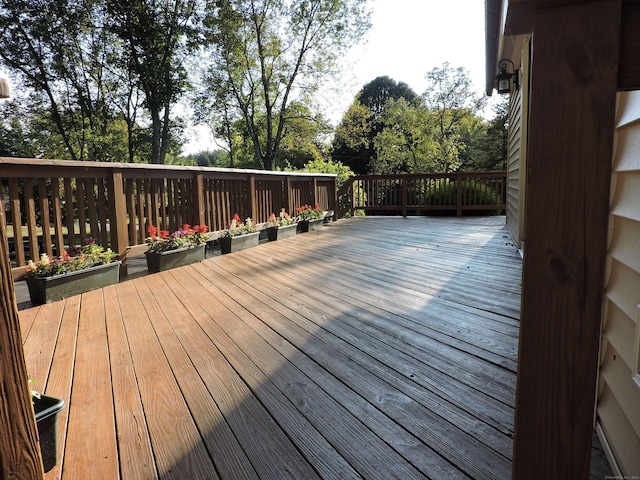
[337,171,507,218]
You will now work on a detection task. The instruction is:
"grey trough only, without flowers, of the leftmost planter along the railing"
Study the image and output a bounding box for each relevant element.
[27,261,122,305]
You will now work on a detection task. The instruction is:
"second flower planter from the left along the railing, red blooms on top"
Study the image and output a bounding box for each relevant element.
[145,224,209,273]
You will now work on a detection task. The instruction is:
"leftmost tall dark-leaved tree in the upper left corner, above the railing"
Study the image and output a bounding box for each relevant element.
[0,0,120,160]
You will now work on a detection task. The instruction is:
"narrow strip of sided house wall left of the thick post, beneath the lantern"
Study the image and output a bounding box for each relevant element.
[507,40,529,248]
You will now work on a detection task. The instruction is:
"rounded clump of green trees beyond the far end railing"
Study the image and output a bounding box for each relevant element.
[332,63,506,174]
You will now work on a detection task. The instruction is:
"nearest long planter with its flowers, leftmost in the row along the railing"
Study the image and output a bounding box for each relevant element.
[26,238,121,304]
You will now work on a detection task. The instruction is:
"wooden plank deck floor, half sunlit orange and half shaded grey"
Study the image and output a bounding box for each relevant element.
[20,217,603,480]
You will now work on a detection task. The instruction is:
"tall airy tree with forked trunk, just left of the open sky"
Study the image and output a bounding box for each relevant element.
[205,0,369,170]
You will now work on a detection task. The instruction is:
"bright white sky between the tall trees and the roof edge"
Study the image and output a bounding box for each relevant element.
[185,0,496,153]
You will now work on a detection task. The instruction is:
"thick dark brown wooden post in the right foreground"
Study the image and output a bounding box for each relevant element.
[513,0,621,480]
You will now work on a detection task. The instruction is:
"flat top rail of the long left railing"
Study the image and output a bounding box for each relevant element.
[0,157,337,179]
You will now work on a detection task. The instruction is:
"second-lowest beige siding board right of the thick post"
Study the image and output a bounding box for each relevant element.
[602,348,640,446]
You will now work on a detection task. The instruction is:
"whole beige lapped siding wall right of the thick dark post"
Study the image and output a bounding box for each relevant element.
[596,92,640,476]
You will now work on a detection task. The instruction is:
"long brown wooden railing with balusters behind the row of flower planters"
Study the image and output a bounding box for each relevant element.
[0,157,336,279]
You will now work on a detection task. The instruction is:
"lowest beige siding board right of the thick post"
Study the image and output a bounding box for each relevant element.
[598,387,640,475]
